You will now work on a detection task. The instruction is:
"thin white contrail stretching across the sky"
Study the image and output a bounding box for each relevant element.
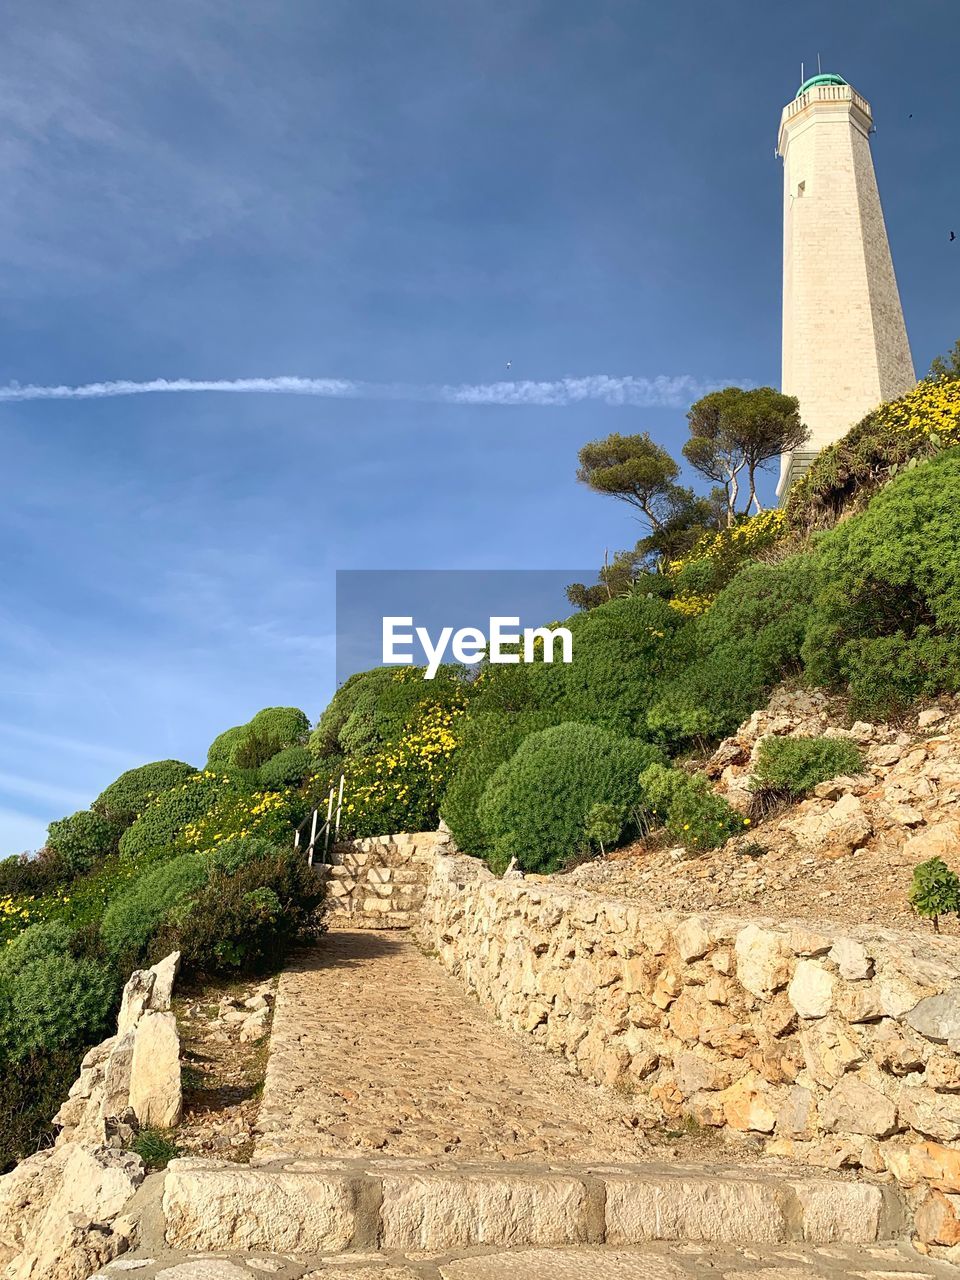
[0,374,753,408]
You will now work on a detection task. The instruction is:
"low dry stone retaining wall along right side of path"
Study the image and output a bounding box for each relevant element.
[420,856,960,1203]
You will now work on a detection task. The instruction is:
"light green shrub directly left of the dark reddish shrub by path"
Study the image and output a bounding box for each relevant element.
[100,854,210,969]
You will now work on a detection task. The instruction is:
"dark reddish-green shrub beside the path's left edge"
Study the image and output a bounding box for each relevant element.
[167,850,325,973]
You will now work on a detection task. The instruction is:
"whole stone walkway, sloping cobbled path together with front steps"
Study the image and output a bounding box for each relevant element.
[106,929,940,1280]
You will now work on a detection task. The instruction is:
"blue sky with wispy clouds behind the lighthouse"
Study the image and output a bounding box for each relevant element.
[0,0,960,852]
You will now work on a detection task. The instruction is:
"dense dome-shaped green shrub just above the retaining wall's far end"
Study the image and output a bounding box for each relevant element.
[479,723,660,872]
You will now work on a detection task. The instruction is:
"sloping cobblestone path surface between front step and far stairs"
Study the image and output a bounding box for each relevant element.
[256,931,648,1161]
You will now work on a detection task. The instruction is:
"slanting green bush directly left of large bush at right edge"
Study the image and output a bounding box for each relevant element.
[646,556,817,750]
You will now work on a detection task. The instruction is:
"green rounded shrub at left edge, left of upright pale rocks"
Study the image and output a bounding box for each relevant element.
[0,923,116,1062]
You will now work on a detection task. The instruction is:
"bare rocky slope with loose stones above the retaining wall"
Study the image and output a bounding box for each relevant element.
[570,687,960,933]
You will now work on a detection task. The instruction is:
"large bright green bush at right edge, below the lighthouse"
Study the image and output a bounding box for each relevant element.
[803,450,960,717]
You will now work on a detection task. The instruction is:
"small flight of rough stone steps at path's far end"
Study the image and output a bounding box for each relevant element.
[328,831,451,929]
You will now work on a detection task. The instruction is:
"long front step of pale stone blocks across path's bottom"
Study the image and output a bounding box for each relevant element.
[163,1158,905,1254]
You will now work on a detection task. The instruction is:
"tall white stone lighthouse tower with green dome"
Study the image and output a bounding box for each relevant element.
[777,74,916,498]
